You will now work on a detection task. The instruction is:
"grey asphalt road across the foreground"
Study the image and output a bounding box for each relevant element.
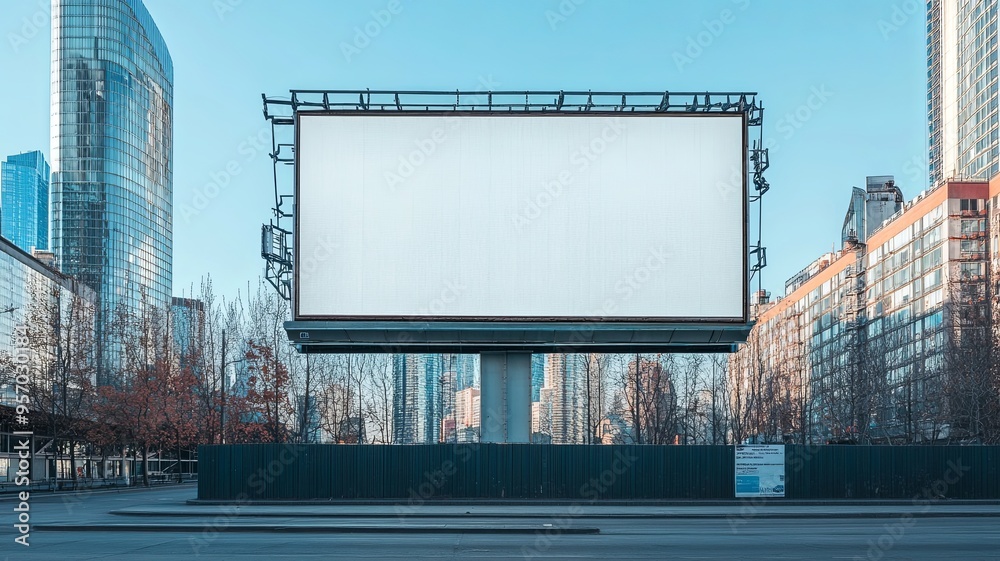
[0,487,1000,561]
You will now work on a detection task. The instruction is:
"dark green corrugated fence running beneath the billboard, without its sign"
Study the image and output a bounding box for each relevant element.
[198,444,1000,502]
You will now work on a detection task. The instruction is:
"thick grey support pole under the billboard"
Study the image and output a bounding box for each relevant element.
[479,352,531,443]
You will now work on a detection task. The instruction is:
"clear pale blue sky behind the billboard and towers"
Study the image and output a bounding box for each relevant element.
[0,0,927,302]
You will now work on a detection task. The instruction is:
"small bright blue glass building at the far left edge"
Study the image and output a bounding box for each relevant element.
[0,150,50,253]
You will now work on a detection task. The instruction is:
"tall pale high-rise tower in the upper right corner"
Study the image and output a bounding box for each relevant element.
[927,0,1000,187]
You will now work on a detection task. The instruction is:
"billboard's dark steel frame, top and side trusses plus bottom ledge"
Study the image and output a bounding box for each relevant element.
[261,89,770,352]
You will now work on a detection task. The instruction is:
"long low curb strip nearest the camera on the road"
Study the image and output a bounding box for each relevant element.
[32,524,601,534]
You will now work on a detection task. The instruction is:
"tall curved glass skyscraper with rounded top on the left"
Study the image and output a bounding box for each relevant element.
[51,0,173,376]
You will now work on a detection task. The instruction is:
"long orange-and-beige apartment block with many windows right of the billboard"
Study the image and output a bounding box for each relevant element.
[729,179,1000,443]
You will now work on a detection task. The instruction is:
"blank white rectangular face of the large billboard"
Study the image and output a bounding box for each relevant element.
[295,112,747,321]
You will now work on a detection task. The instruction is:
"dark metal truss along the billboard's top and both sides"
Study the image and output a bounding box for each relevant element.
[261,90,769,306]
